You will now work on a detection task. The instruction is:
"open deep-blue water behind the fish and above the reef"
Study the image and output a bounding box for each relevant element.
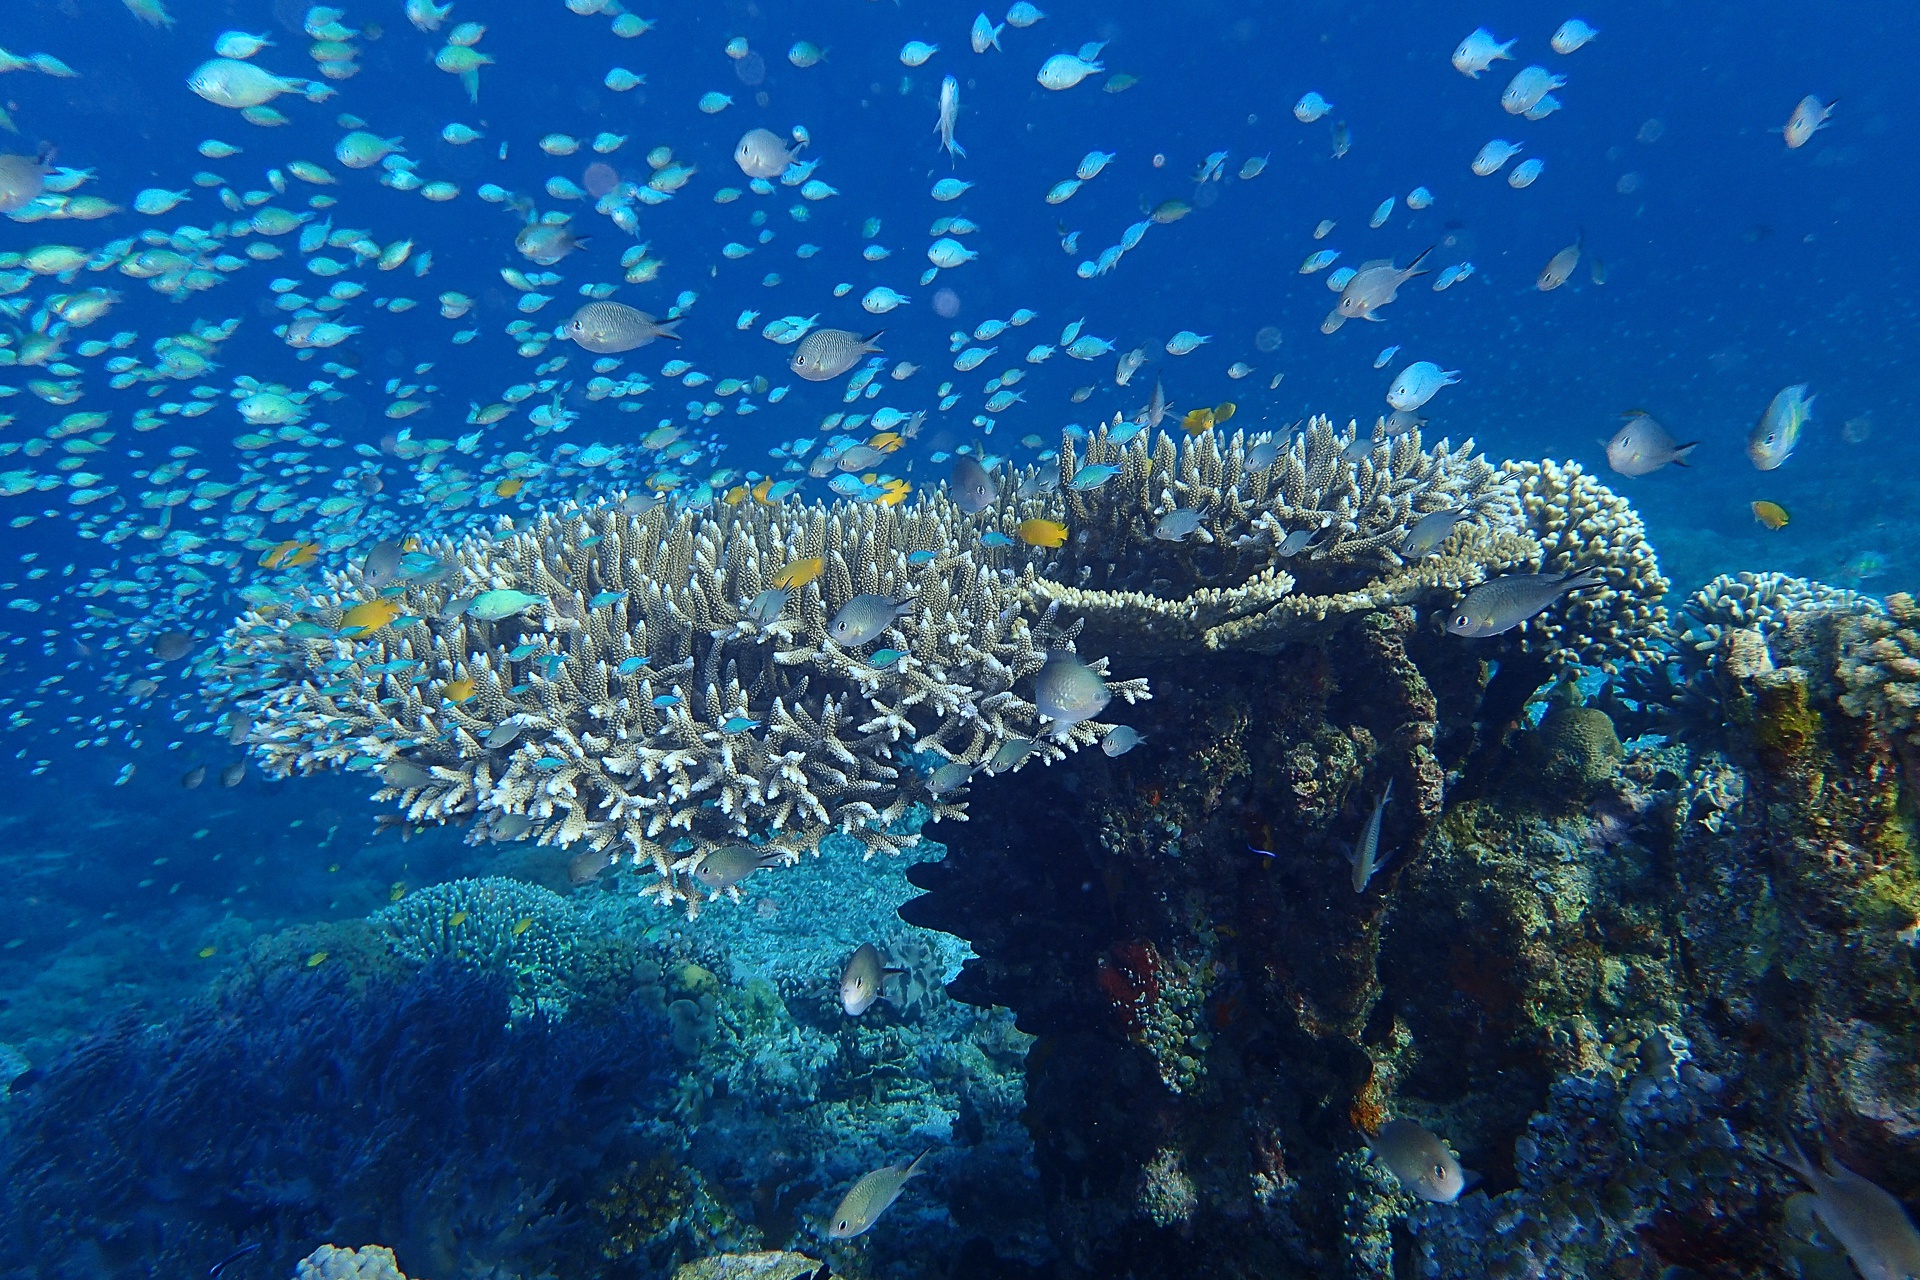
[0,0,1920,1265]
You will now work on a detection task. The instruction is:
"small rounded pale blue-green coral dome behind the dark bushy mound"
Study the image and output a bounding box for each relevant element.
[374,875,582,1017]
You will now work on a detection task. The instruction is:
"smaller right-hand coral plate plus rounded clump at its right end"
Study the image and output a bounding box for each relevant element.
[1027,433,1667,666]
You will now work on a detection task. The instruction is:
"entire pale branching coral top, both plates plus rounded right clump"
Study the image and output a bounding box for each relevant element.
[211,418,1667,912]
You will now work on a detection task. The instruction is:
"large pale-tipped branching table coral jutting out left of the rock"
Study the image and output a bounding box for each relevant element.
[214,497,1148,912]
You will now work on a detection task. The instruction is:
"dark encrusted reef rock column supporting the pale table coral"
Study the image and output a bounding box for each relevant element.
[902,610,1920,1278]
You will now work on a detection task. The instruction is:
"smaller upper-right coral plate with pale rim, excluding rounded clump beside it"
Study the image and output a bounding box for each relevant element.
[1029,418,1532,654]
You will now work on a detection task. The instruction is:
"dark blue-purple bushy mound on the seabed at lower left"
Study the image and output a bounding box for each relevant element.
[0,963,666,1280]
